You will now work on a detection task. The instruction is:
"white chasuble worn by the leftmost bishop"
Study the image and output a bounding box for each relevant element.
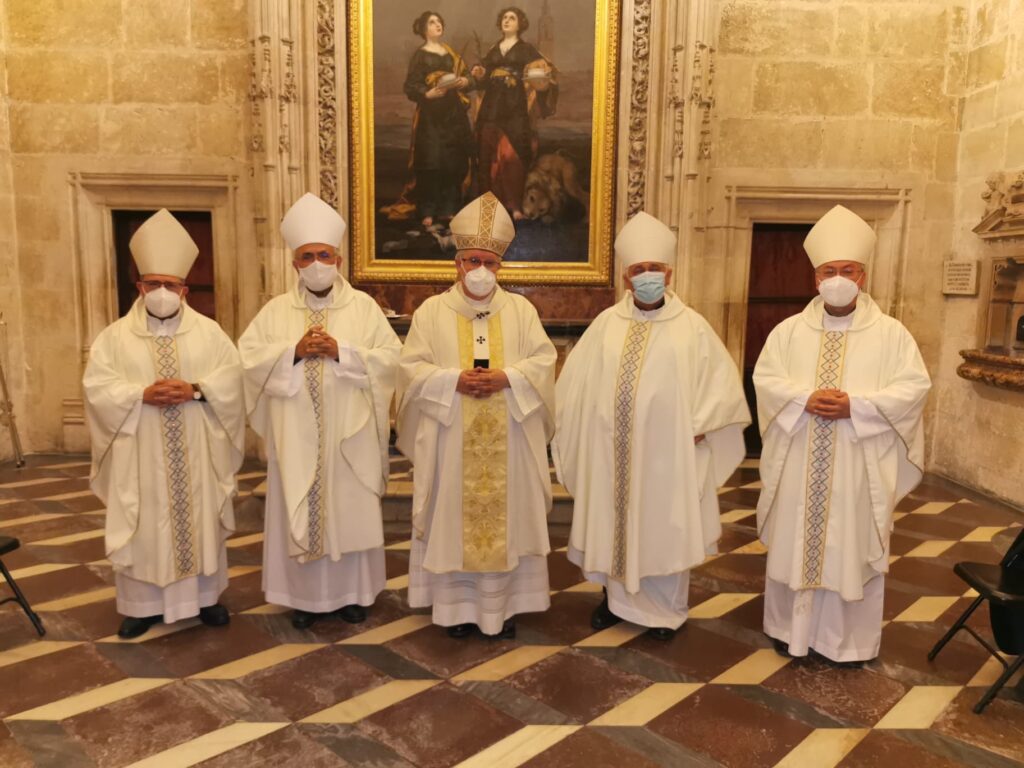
[83,300,245,593]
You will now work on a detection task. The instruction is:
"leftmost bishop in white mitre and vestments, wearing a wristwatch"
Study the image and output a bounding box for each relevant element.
[83,210,245,639]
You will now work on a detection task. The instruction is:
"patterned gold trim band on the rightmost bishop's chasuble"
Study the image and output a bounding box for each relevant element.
[803,331,846,589]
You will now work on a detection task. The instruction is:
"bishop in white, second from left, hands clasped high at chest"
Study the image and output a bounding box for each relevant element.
[239,194,401,629]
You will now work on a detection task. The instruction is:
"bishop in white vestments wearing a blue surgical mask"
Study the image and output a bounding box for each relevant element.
[552,213,751,640]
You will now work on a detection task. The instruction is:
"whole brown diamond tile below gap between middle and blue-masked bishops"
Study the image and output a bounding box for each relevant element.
[505,648,650,723]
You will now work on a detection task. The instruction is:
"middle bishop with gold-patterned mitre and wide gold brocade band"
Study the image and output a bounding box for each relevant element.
[397,193,555,638]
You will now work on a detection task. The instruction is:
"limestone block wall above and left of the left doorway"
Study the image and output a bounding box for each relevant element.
[0,0,250,451]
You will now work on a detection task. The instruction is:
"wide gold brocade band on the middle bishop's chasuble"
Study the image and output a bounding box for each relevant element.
[458,314,508,572]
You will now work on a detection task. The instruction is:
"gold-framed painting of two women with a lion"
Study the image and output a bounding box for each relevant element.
[347,0,620,285]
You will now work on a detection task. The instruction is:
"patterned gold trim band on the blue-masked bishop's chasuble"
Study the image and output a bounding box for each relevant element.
[611,321,651,582]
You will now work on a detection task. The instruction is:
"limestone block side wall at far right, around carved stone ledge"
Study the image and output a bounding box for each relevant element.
[931,0,1024,506]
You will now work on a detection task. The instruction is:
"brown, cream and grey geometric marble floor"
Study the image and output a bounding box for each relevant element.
[0,457,1024,768]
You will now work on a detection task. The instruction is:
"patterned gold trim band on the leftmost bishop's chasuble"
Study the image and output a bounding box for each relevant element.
[153,336,199,579]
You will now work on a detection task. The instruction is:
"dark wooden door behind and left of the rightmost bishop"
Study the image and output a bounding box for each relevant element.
[743,224,817,456]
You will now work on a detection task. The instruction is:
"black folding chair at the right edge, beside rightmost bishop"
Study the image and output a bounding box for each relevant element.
[928,528,1024,715]
